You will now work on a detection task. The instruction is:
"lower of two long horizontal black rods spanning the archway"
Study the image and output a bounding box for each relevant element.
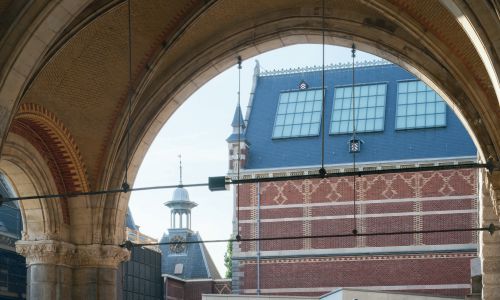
[125,224,500,247]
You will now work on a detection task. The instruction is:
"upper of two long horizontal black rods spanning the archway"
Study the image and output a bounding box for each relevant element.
[3,161,492,202]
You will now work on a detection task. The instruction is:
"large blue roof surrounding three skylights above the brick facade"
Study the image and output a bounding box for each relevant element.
[245,64,476,169]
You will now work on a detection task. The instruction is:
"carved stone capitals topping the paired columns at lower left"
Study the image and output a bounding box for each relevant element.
[16,240,130,268]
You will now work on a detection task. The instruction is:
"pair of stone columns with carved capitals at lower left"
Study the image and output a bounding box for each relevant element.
[16,240,130,300]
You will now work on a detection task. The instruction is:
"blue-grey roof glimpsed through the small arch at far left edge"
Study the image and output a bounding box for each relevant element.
[0,173,23,238]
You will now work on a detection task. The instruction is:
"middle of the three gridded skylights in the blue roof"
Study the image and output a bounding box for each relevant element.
[330,83,387,134]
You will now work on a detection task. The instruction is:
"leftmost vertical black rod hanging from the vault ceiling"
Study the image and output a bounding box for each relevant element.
[122,0,132,193]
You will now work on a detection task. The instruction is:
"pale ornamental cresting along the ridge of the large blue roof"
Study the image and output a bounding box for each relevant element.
[258,59,393,77]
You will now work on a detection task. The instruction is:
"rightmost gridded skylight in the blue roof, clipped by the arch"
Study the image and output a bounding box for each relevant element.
[396,81,446,129]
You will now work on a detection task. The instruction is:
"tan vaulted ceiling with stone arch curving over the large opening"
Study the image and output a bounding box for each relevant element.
[0,0,500,187]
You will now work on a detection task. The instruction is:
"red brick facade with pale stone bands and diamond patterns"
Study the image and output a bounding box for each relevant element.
[233,169,477,296]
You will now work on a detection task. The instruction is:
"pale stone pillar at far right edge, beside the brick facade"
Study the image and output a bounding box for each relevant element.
[479,171,500,300]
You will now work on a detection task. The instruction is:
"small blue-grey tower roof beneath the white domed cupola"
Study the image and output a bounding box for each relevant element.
[160,233,220,279]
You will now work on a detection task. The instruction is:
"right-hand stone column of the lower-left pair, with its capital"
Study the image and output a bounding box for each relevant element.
[71,245,130,300]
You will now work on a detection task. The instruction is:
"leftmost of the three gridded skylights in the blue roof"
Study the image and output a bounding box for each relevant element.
[273,89,322,138]
